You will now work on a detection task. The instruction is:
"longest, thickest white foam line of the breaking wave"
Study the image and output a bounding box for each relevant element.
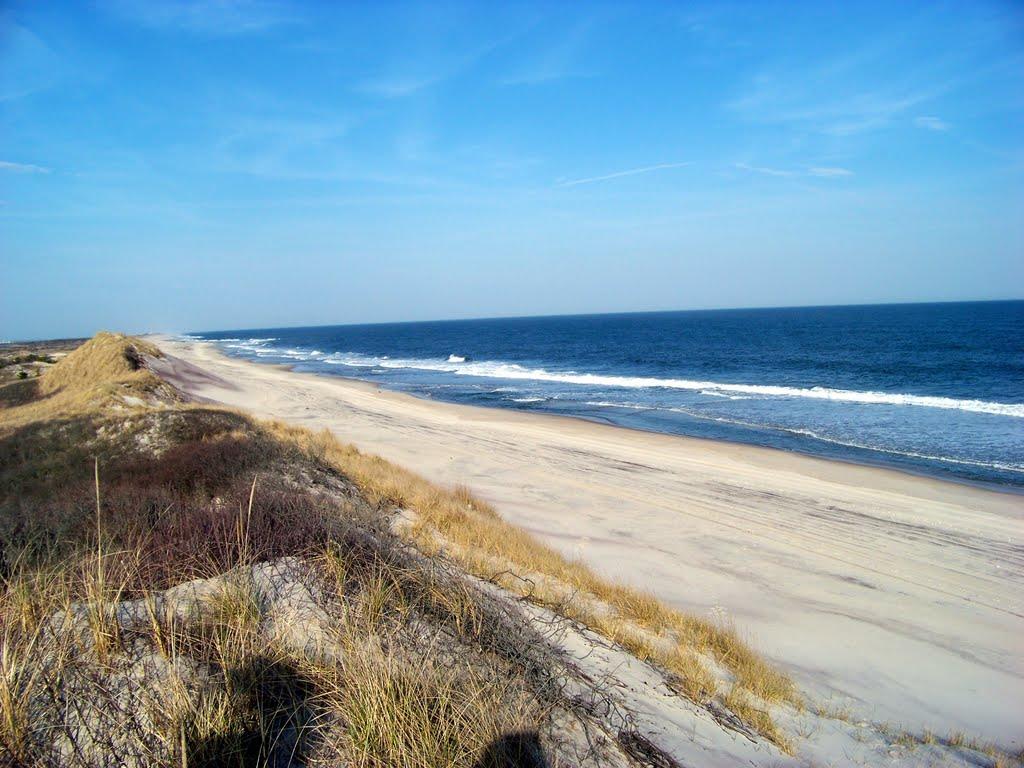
[309,353,1024,419]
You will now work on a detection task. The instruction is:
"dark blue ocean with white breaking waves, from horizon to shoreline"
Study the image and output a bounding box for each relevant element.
[188,301,1024,489]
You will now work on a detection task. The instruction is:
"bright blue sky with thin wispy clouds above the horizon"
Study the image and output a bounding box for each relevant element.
[0,0,1024,338]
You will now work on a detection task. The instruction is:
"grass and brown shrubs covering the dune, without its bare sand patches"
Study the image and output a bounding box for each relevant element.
[0,334,800,768]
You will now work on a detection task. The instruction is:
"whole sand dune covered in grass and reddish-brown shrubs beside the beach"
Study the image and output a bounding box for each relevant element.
[0,334,1004,767]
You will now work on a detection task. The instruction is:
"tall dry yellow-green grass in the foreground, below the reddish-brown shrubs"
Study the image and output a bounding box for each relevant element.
[0,520,545,768]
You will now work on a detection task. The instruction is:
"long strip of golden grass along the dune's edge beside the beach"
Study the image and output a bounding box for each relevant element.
[267,422,802,748]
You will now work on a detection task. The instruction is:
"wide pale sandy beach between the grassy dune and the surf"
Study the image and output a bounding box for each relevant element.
[156,338,1024,750]
